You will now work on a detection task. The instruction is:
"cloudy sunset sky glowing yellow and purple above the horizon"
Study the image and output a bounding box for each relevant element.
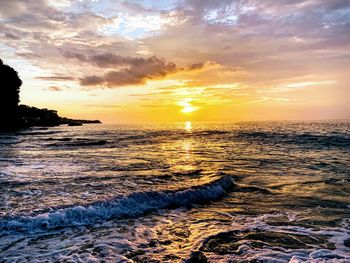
[0,0,350,123]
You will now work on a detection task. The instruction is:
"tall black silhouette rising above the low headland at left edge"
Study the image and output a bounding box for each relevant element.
[0,59,22,130]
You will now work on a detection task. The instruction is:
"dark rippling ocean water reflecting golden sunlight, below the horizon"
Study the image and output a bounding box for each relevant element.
[0,121,350,262]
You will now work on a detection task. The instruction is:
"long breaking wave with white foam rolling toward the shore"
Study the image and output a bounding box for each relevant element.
[0,175,234,232]
